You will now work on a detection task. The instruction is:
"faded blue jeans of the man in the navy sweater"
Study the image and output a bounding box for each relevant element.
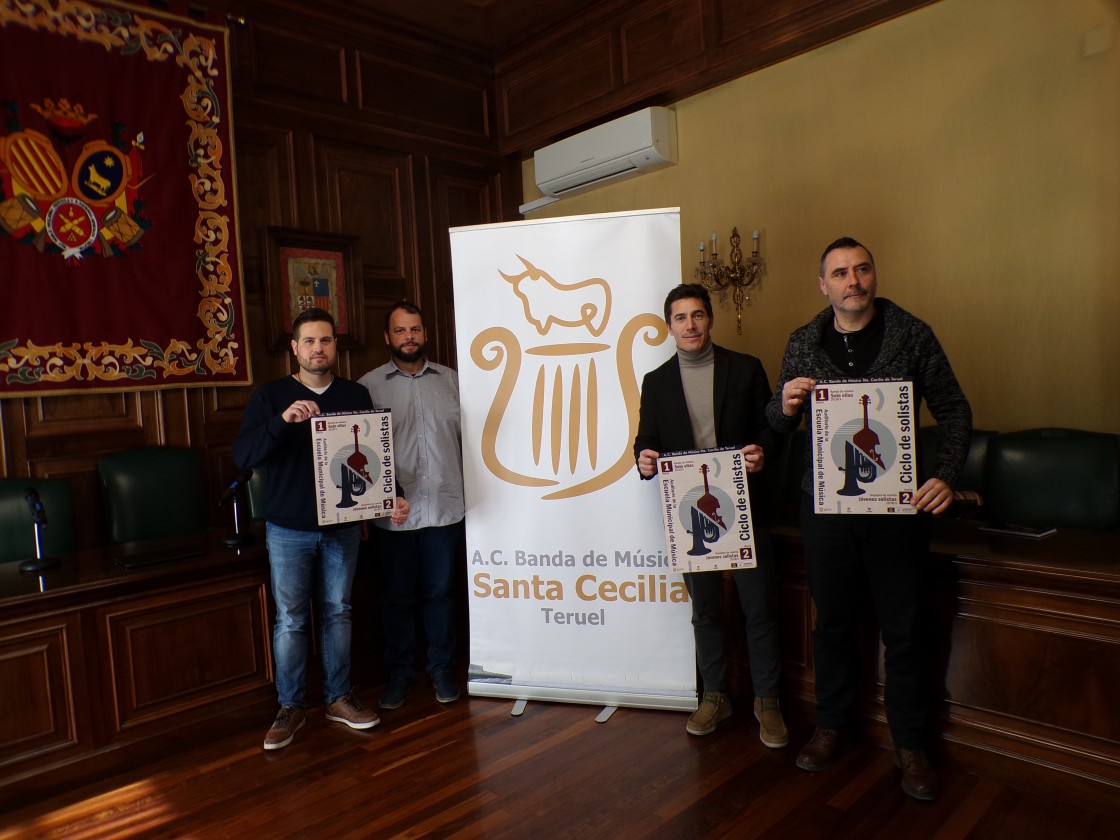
[265,522,362,709]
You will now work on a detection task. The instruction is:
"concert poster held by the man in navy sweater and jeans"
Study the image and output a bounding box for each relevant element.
[311,410,396,525]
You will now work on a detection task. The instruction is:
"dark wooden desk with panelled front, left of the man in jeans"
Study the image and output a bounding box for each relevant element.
[0,542,276,809]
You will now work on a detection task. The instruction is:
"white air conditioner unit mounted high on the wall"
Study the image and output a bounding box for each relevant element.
[533,108,676,198]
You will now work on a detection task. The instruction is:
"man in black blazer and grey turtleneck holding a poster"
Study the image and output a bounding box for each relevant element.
[634,283,790,748]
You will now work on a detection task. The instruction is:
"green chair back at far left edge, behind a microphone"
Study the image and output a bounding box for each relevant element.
[0,478,77,562]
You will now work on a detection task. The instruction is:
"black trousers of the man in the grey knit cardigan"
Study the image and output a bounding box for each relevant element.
[801,493,931,749]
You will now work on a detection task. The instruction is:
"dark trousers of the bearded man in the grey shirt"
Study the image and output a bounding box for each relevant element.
[376,522,463,680]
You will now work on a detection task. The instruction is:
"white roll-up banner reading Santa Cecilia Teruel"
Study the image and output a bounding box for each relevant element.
[450,208,696,709]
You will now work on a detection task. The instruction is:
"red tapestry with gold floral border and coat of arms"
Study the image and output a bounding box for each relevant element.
[0,0,250,396]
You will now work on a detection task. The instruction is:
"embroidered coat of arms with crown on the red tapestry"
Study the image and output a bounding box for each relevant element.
[0,99,151,261]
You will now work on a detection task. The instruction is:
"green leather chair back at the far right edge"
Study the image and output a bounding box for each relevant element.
[984,429,1120,531]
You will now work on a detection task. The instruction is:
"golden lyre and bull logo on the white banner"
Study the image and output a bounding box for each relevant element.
[470,255,668,500]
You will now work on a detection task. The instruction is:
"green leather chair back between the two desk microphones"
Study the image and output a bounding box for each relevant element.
[97,446,209,543]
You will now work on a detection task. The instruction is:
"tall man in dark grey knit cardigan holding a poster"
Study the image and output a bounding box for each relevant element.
[766,237,972,800]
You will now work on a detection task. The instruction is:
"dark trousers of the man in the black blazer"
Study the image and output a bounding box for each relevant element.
[684,528,782,697]
